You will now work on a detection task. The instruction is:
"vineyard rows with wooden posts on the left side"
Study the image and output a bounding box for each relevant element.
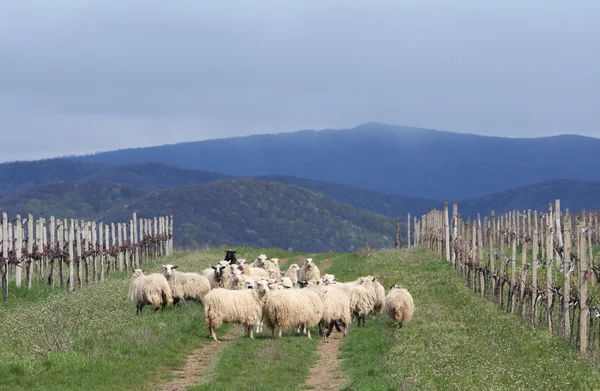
[0,213,173,301]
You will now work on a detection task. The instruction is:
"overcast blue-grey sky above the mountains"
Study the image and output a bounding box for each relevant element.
[0,0,600,161]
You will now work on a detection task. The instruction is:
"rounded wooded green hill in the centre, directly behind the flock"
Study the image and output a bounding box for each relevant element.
[97,179,395,252]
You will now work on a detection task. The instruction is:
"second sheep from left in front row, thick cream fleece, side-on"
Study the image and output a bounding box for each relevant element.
[264,283,325,338]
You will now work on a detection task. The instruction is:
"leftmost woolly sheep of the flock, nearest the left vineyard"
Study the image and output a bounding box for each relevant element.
[129,269,173,314]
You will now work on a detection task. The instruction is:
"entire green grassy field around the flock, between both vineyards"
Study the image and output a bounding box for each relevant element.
[0,248,600,391]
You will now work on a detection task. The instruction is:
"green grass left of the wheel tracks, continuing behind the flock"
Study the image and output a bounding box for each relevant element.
[0,247,296,390]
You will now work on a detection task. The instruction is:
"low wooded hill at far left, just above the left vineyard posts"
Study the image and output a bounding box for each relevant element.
[0,181,147,219]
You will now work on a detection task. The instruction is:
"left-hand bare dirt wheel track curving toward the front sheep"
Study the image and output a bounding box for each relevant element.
[157,325,243,391]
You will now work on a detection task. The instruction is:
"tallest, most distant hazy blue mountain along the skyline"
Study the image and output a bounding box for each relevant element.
[71,123,600,200]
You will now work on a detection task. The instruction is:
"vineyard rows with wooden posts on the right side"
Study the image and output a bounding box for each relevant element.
[413,200,600,359]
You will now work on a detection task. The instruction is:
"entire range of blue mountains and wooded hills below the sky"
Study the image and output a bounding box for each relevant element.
[0,123,600,251]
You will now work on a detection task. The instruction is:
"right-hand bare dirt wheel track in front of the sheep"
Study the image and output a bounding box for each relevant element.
[306,330,347,391]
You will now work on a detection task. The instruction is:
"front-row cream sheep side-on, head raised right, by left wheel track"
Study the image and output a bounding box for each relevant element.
[204,281,268,343]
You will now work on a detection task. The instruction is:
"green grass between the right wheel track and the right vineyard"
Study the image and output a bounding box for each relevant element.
[329,250,600,390]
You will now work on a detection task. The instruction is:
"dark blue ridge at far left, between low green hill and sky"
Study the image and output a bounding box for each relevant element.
[0,158,232,198]
